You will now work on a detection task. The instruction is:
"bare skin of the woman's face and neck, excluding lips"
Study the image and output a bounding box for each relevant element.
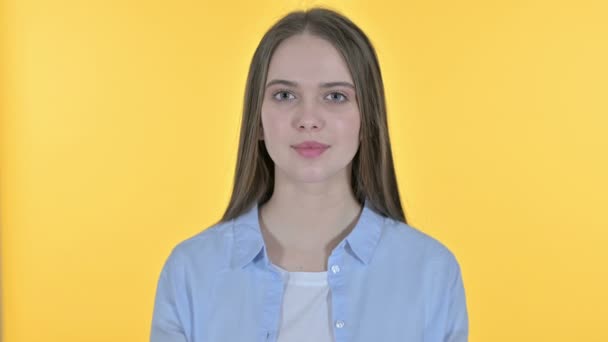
[259,34,362,272]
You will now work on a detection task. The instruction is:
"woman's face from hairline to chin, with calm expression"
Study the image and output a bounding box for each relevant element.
[262,34,361,183]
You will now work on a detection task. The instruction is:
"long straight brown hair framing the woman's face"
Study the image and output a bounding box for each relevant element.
[220,7,407,223]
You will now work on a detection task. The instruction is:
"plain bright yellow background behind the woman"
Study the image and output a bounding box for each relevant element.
[0,0,608,342]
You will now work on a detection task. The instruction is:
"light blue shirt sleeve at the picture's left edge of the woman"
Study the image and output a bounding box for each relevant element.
[150,248,188,342]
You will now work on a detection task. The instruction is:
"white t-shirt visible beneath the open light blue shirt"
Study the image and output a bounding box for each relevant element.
[273,265,334,342]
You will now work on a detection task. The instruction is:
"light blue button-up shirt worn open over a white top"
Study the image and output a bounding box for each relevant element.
[150,202,468,342]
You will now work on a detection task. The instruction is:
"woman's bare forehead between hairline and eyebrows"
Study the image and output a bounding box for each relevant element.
[267,33,352,85]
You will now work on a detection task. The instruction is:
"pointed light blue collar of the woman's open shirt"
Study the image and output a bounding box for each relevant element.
[230,200,385,268]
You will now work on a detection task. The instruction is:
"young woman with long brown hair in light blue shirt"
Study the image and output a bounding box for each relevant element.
[151,8,468,342]
